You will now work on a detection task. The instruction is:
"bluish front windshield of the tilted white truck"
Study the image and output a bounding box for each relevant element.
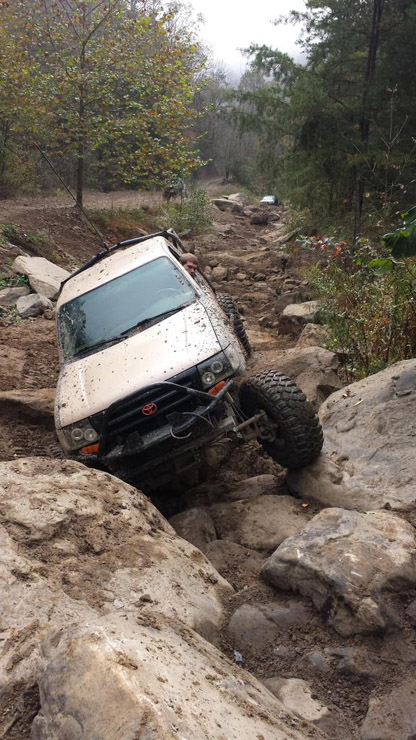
[59,257,195,359]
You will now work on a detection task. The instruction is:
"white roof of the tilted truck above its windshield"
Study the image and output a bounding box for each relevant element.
[57,236,169,309]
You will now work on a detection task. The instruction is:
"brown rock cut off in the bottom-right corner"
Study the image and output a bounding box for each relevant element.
[360,678,416,740]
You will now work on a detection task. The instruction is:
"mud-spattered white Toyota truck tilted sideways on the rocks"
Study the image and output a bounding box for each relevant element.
[55,230,323,490]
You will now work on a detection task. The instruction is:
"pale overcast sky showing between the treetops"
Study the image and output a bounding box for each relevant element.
[189,0,304,73]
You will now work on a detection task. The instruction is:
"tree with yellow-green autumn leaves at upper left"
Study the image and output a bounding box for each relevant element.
[0,0,205,204]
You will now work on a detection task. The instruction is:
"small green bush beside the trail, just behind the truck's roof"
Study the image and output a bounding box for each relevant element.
[159,186,211,233]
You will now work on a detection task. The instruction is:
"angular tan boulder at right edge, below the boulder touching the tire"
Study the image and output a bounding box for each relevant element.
[262,509,416,635]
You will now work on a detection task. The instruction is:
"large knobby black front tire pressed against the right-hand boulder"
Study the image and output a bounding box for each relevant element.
[240,370,323,470]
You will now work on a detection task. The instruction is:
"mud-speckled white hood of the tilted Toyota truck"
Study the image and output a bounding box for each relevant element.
[56,303,228,427]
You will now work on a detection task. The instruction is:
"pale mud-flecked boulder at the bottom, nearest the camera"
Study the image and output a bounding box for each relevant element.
[32,616,326,740]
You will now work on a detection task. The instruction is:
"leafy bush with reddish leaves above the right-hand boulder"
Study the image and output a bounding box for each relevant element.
[310,240,416,381]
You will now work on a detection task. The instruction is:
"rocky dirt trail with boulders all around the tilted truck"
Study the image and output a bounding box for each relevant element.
[0,192,416,740]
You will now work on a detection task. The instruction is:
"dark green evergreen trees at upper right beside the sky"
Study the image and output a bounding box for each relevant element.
[231,0,416,228]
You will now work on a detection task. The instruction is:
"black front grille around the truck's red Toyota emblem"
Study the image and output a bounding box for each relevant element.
[100,370,202,453]
